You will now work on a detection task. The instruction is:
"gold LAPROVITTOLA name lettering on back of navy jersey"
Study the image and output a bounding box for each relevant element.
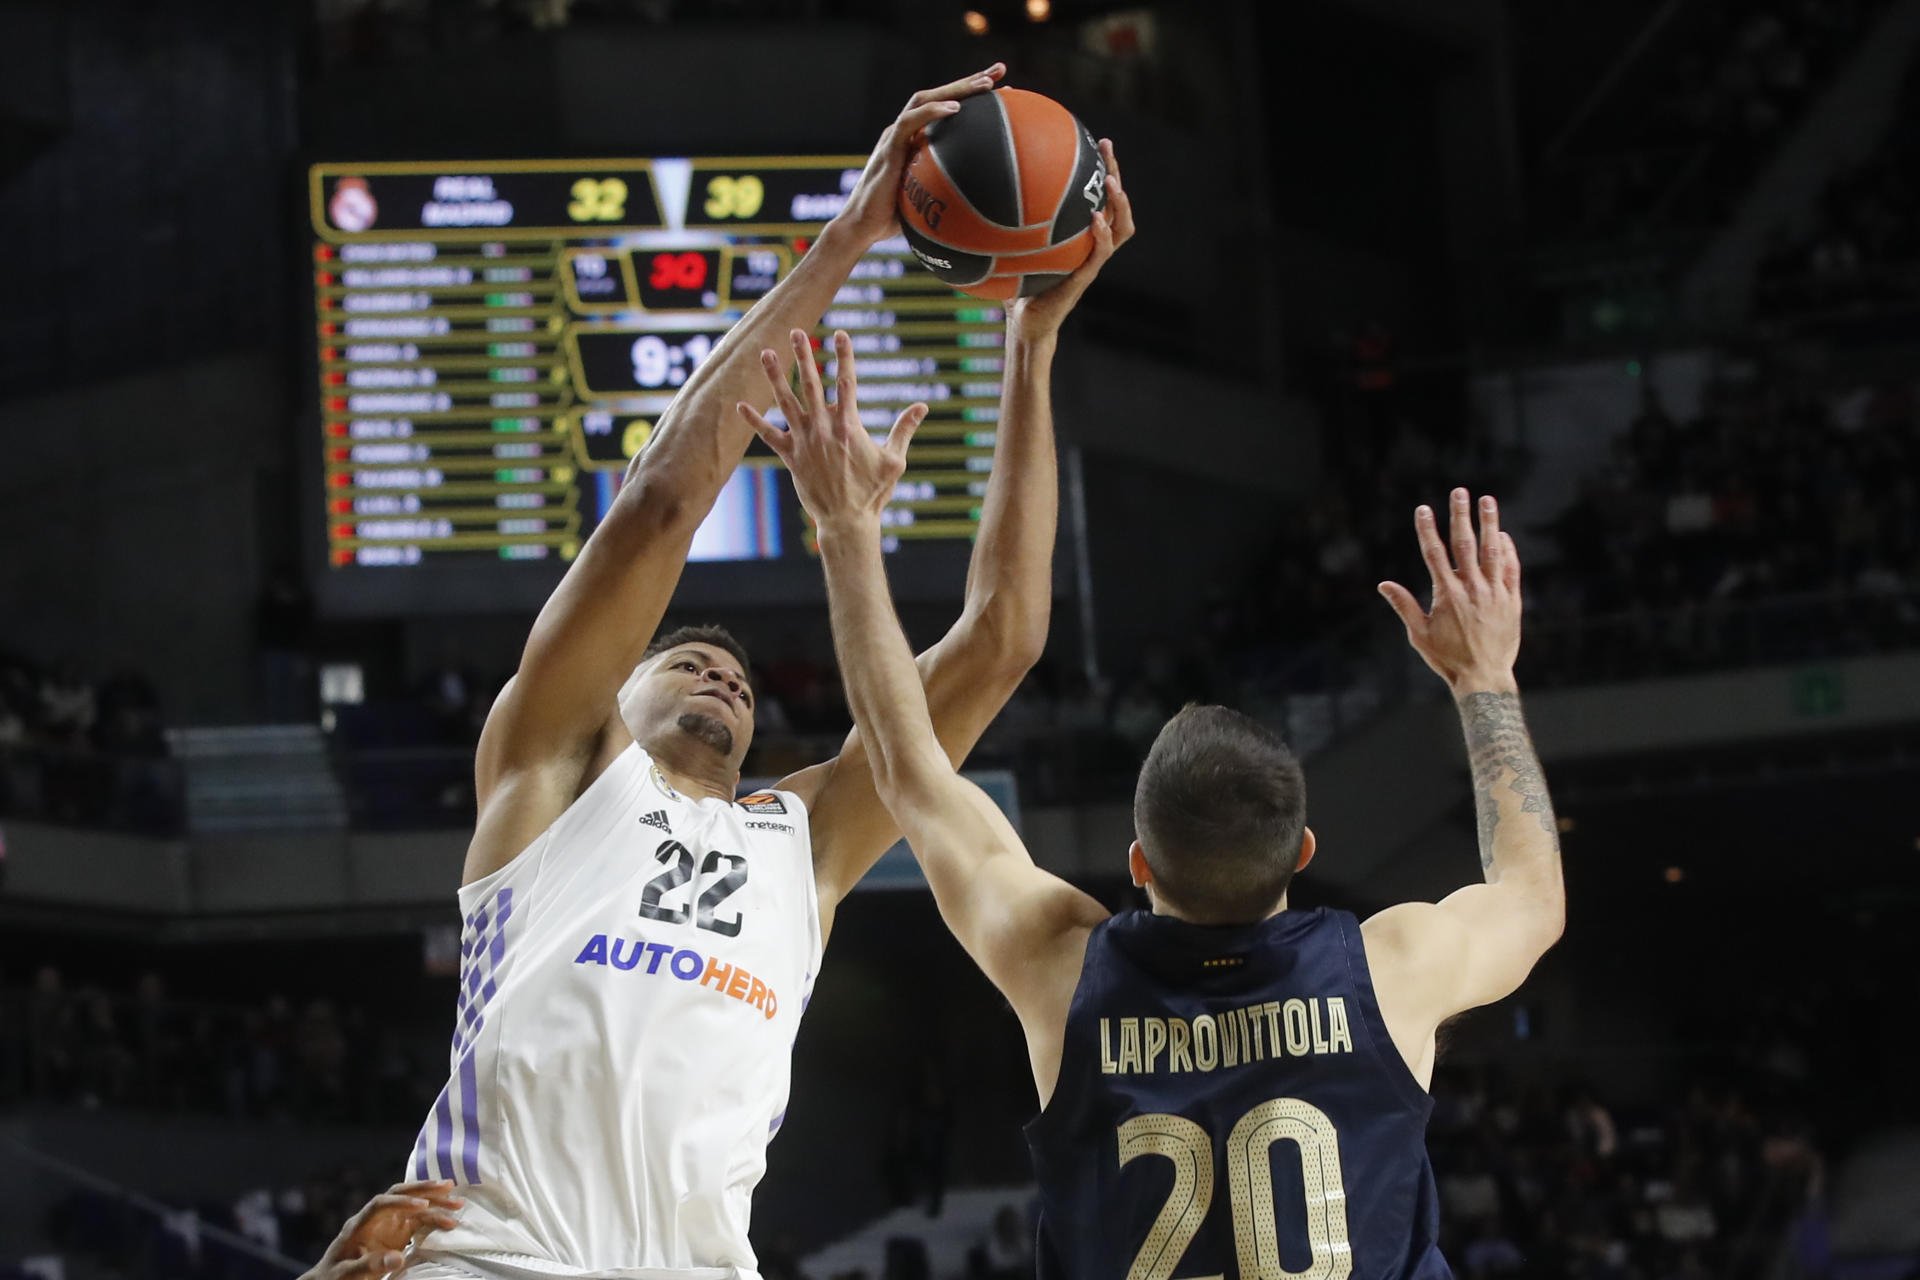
[1100,996,1354,1075]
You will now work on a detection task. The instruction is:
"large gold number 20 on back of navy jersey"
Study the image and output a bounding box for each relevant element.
[1119,1098,1354,1280]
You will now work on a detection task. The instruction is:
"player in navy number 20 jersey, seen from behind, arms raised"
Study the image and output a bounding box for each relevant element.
[749,314,1565,1280]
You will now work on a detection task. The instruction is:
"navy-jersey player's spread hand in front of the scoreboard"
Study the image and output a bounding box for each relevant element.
[739,328,927,526]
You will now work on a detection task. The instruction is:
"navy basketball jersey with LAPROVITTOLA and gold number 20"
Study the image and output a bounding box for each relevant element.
[1027,910,1452,1280]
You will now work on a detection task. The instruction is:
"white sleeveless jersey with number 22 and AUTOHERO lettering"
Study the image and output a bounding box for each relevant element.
[409,745,822,1280]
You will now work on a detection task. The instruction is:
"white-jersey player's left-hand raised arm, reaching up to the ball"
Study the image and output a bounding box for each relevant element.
[467,63,1004,881]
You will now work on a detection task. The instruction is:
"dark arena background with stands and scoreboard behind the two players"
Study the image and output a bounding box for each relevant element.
[0,0,1920,1280]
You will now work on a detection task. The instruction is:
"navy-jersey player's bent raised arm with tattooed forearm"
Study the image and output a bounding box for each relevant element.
[1363,489,1567,1080]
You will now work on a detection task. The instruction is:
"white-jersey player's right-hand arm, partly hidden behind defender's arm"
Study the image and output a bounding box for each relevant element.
[780,138,1135,927]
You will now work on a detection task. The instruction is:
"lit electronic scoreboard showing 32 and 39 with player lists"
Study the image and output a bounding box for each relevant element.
[309,157,1004,568]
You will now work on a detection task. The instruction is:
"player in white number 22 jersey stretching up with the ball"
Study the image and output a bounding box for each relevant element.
[409,65,1131,1280]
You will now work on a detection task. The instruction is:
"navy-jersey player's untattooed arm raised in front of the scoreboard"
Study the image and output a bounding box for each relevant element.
[741,334,1106,1098]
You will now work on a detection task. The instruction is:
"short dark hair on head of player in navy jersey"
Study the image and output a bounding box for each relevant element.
[1133,704,1308,925]
